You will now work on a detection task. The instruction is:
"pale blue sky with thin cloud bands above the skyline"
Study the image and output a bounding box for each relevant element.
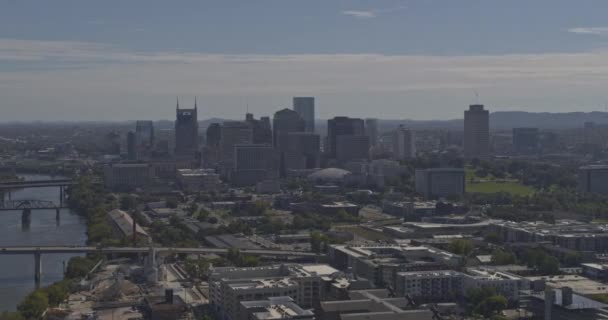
[0,0,608,121]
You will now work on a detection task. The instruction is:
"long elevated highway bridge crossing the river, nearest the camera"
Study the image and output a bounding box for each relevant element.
[0,246,323,258]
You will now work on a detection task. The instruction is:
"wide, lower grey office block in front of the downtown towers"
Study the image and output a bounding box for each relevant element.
[231,144,279,186]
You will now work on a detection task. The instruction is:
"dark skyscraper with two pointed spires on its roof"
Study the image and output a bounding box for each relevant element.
[175,99,198,155]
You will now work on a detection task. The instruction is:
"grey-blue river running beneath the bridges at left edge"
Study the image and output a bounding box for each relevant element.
[0,174,87,311]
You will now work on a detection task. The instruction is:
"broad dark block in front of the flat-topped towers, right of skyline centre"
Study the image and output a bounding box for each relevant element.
[283,132,321,170]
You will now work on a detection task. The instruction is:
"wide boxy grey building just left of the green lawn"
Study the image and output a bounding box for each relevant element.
[416,168,466,198]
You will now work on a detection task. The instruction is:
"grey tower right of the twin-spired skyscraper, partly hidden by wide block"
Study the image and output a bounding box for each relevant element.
[220,121,253,169]
